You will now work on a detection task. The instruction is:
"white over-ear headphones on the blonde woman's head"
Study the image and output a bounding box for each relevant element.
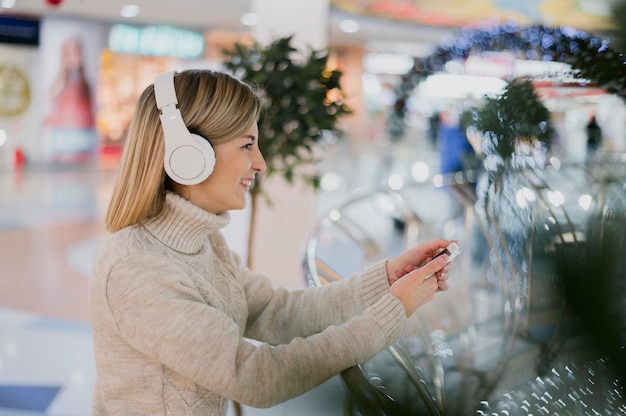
[154,71,215,185]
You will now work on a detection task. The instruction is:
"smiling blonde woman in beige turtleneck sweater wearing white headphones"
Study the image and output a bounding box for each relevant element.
[89,70,450,415]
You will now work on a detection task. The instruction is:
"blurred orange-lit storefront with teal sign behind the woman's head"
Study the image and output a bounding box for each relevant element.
[96,25,251,167]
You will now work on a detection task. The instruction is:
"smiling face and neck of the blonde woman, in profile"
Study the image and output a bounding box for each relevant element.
[181,123,266,214]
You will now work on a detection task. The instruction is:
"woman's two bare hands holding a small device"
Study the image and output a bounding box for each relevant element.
[386,239,455,316]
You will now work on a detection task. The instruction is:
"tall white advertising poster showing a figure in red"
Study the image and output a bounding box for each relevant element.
[40,18,107,164]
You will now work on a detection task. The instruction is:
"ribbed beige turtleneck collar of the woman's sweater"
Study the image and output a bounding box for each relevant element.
[143,192,230,254]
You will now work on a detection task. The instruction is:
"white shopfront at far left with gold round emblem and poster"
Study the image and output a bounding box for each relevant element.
[0,18,107,169]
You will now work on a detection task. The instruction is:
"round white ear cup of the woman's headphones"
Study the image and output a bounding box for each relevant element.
[165,133,215,185]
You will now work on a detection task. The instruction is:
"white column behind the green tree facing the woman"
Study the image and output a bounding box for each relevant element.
[250,0,329,288]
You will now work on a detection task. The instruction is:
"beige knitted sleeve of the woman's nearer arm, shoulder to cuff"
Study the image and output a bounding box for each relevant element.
[100,254,407,407]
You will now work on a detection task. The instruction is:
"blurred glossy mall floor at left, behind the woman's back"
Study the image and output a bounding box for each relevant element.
[0,170,102,416]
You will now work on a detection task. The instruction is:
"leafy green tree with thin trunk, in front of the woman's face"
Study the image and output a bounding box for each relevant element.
[224,36,351,264]
